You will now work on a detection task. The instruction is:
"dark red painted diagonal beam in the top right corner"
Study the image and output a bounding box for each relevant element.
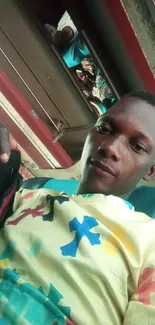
[103,0,155,92]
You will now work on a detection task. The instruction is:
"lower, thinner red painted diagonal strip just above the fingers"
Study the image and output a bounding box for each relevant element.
[0,107,51,169]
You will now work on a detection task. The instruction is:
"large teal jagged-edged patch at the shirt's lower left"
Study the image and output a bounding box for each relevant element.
[0,269,71,325]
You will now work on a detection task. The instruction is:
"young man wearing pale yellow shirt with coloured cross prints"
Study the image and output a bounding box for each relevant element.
[0,93,155,325]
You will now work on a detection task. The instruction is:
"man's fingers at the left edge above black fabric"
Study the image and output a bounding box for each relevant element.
[0,122,17,163]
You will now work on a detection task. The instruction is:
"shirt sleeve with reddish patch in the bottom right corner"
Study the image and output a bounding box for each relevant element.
[123,266,155,325]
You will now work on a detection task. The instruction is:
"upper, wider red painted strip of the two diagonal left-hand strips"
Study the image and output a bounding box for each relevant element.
[0,69,72,168]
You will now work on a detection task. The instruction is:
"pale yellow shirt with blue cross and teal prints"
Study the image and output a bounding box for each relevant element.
[0,189,155,325]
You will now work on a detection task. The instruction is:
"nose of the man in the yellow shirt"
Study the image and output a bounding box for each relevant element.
[98,138,122,161]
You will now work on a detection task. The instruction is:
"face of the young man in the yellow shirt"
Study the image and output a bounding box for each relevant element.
[81,97,155,195]
